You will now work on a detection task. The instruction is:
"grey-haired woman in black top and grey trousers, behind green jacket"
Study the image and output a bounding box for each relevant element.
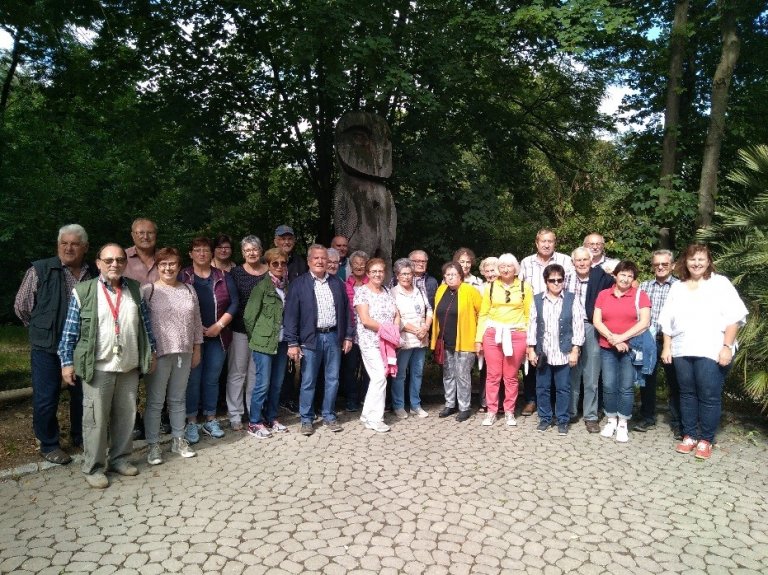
[227,235,269,431]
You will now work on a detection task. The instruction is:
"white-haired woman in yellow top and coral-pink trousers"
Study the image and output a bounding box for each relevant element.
[475,254,533,426]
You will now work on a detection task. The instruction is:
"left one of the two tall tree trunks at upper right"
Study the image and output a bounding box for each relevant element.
[658,0,689,249]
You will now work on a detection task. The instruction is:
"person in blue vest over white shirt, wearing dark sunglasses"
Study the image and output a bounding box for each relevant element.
[528,264,585,435]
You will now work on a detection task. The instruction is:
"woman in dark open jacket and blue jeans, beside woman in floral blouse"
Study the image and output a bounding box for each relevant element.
[180,237,240,444]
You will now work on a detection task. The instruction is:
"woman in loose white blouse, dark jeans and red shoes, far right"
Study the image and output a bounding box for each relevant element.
[659,244,748,459]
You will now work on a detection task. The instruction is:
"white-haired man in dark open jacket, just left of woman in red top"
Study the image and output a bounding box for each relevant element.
[568,247,613,433]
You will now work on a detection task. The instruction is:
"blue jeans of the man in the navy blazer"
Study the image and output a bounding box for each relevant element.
[299,331,341,423]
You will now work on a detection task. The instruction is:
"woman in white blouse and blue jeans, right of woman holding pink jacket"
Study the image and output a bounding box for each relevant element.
[390,258,432,419]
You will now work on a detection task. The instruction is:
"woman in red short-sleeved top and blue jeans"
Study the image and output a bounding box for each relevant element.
[592,261,651,443]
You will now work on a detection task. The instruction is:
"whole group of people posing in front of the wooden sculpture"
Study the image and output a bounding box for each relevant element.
[15,223,747,488]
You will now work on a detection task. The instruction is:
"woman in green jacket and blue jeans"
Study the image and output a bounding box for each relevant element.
[243,248,288,439]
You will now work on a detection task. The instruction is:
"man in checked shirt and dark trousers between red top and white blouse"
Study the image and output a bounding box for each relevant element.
[632,250,683,440]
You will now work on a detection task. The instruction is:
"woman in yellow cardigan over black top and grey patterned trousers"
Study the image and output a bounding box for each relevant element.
[430,262,482,421]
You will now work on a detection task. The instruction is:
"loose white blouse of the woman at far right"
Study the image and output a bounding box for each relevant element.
[659,274,749,361]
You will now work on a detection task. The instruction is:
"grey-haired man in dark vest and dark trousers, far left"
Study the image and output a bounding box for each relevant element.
[14,224,91,465]
